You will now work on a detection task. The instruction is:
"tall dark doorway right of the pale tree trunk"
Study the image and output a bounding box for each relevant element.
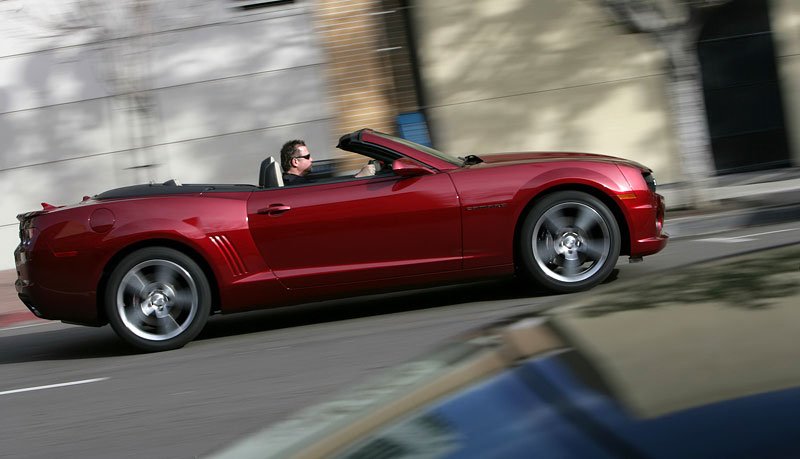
[698,0,791,174]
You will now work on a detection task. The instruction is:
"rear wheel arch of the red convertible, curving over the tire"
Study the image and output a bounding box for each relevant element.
[95,238,220,321]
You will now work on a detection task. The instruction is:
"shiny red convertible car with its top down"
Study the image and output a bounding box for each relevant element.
[15,129,667,351]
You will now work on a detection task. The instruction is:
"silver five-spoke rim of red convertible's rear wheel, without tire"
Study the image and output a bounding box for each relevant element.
[116,259,199,341]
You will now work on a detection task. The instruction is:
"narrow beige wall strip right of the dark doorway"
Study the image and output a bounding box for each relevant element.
[770,0,800,166]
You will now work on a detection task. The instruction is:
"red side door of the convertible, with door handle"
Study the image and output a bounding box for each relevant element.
[248,173,462,288]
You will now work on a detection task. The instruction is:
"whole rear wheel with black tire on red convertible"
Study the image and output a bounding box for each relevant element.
[104,247,211,352]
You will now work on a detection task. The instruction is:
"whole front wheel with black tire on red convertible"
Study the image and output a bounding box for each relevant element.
[518,191,621,293]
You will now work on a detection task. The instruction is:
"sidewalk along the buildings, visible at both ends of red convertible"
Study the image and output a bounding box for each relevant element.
[0,167,800,329]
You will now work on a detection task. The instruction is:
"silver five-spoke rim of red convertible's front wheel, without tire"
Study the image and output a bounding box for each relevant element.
[531,201,612,283]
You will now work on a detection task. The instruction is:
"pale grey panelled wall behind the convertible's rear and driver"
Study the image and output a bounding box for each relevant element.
[0,0,332,269]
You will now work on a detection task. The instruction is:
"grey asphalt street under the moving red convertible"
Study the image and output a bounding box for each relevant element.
[0,222,800,458]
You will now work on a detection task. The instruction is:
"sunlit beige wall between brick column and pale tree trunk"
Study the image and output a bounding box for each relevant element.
[414,0,680,183]
